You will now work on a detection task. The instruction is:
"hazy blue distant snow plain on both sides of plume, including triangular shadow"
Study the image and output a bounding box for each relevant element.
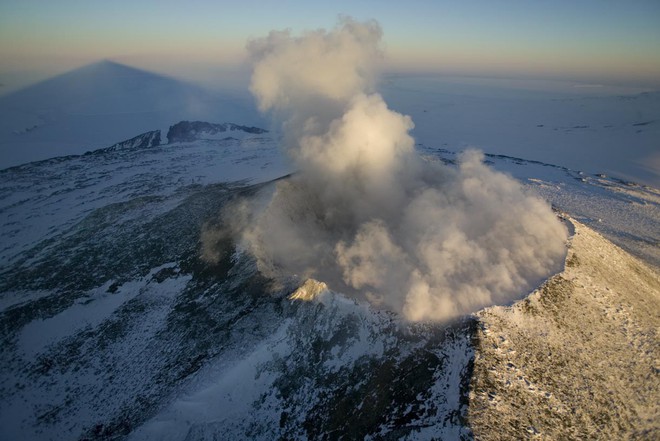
[0,61,660,188]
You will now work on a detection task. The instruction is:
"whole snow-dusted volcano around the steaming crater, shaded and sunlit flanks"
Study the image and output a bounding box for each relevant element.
[0,122,660,440]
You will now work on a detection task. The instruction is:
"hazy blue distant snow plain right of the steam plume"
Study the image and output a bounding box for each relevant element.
[382,75,660,188]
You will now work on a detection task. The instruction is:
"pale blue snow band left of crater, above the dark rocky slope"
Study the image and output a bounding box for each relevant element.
[0,133,290,264]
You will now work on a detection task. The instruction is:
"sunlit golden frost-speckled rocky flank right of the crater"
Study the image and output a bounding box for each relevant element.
[468,221,660,440]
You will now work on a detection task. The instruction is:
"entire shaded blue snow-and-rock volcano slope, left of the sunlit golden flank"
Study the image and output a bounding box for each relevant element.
[0,124,472,440]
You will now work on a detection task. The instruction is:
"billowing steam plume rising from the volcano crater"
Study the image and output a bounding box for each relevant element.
[213,18,567,321]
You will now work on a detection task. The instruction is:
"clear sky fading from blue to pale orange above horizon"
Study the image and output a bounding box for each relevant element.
[0,0,660,91]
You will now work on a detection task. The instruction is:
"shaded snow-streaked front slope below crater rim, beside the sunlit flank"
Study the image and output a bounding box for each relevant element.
[129,284,472,440]
